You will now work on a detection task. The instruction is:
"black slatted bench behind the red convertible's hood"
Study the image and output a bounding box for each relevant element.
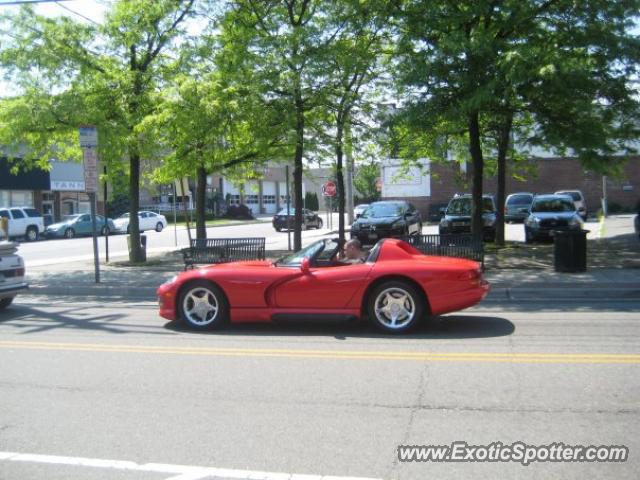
[181,237,265,270]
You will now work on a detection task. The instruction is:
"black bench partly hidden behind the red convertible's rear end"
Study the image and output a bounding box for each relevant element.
[403,234,484,269]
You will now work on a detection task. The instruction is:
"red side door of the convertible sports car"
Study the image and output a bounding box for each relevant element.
[275,263,372,310]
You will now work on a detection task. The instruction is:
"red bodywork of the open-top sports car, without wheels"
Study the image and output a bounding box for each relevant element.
[157,239,489,332]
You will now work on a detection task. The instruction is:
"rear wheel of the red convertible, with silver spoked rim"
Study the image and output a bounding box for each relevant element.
[367,280,426,333]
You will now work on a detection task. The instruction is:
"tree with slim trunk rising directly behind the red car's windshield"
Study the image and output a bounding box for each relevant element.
[223,0,341,250]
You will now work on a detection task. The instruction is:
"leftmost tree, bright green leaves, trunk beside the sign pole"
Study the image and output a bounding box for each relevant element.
[0,0,195,262]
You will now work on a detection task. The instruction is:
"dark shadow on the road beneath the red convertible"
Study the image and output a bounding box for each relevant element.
[165,315,515,341]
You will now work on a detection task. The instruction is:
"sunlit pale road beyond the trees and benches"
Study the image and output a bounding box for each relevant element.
[15,214,604,267]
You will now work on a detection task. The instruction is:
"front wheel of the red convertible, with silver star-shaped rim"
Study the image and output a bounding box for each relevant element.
[177,280,229,330]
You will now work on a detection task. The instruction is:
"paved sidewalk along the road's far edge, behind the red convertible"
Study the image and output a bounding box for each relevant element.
[25,246,640,303]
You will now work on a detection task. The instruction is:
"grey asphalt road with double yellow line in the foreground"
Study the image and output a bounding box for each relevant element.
[0,296,640,480]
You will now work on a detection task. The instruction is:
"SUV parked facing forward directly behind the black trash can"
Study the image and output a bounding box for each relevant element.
[524,195,583,243]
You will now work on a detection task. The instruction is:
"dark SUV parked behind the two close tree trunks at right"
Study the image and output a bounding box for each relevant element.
[438,194,496,242]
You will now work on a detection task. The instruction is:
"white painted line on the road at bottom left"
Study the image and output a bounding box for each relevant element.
[0,452,379,480]
